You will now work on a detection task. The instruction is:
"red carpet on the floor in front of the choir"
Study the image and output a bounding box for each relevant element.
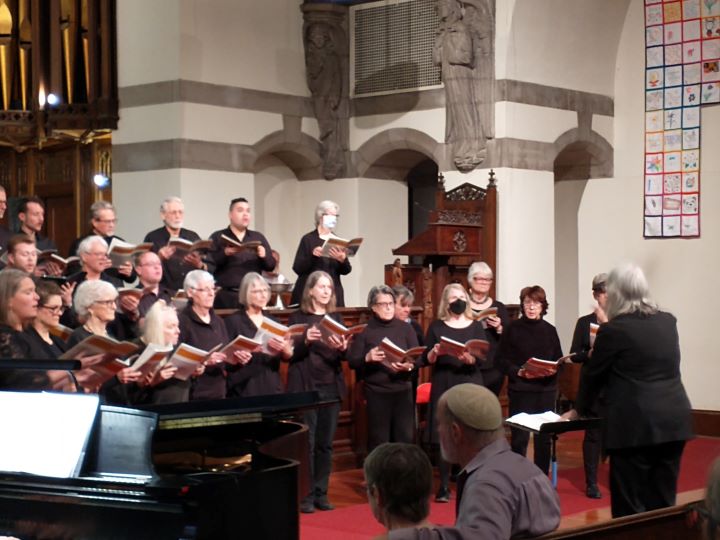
[300,438,720,540]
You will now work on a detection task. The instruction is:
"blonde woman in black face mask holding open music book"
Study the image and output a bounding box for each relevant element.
[423,283,486,502]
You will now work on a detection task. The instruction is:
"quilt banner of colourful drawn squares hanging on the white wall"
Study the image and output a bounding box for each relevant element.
[644,0,720,238]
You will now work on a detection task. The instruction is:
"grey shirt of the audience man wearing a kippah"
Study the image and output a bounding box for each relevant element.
[389,439,560,540]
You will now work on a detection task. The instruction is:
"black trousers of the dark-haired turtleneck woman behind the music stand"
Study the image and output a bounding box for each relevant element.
[508,388,557,474]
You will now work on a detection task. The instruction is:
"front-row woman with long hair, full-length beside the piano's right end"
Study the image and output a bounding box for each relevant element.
[288,270,348,513]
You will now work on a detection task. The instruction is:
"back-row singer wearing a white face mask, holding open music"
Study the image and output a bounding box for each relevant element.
[290,201,352,307]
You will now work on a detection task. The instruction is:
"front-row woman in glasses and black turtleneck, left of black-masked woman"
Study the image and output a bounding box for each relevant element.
[348,285,417,451]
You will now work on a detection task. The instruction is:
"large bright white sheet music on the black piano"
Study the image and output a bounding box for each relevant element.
[0,392,100,478]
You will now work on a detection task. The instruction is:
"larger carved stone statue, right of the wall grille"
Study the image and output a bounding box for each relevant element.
[433,0,495,172]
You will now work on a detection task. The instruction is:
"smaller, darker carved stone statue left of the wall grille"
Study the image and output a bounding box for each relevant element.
[305,21,345,180]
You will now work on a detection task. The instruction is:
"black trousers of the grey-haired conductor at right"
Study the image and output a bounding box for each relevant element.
[608,441,685,517]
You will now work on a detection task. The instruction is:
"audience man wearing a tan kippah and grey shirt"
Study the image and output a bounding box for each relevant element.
[389,383,560,540]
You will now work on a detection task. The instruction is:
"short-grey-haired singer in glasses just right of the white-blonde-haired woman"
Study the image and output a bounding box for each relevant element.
[178,270,228,400]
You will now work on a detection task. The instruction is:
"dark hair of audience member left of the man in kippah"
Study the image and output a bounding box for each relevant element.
[363,443,433,523]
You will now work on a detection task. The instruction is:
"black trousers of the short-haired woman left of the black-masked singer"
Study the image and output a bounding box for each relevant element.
[365,386,415,452]
